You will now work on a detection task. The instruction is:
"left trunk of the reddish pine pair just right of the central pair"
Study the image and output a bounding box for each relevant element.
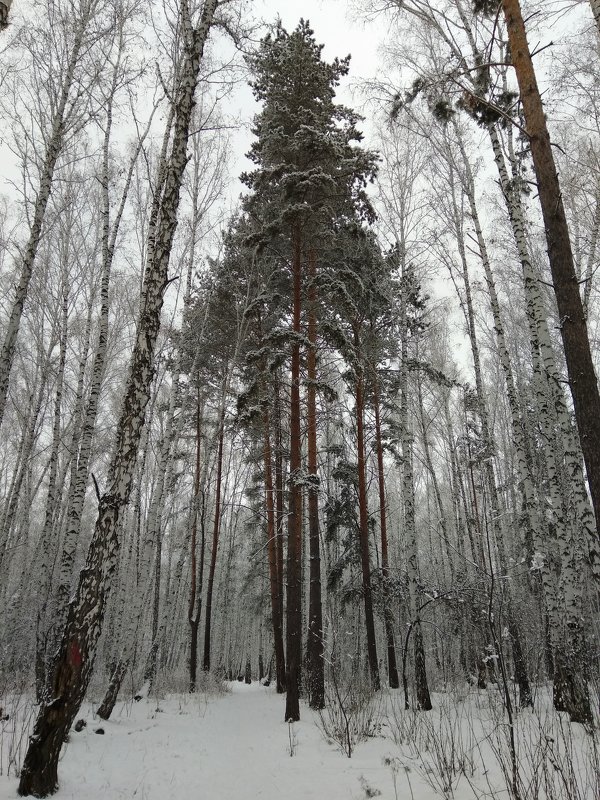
[354,327,381,691]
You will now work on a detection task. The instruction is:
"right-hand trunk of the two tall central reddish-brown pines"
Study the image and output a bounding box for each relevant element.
[306,248,325,708]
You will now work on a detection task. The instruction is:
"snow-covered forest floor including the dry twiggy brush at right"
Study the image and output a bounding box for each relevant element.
[0,683,600,800]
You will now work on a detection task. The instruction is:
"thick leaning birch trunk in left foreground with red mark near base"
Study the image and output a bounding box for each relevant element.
[18,0,218,797]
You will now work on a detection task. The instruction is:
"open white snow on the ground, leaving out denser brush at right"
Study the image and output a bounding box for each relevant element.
[0,682,595,800]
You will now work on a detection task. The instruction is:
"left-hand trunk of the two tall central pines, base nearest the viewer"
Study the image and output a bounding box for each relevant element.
[285,224,302,722]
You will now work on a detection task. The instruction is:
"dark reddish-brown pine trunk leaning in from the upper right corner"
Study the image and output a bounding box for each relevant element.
[502,0,600,580]
